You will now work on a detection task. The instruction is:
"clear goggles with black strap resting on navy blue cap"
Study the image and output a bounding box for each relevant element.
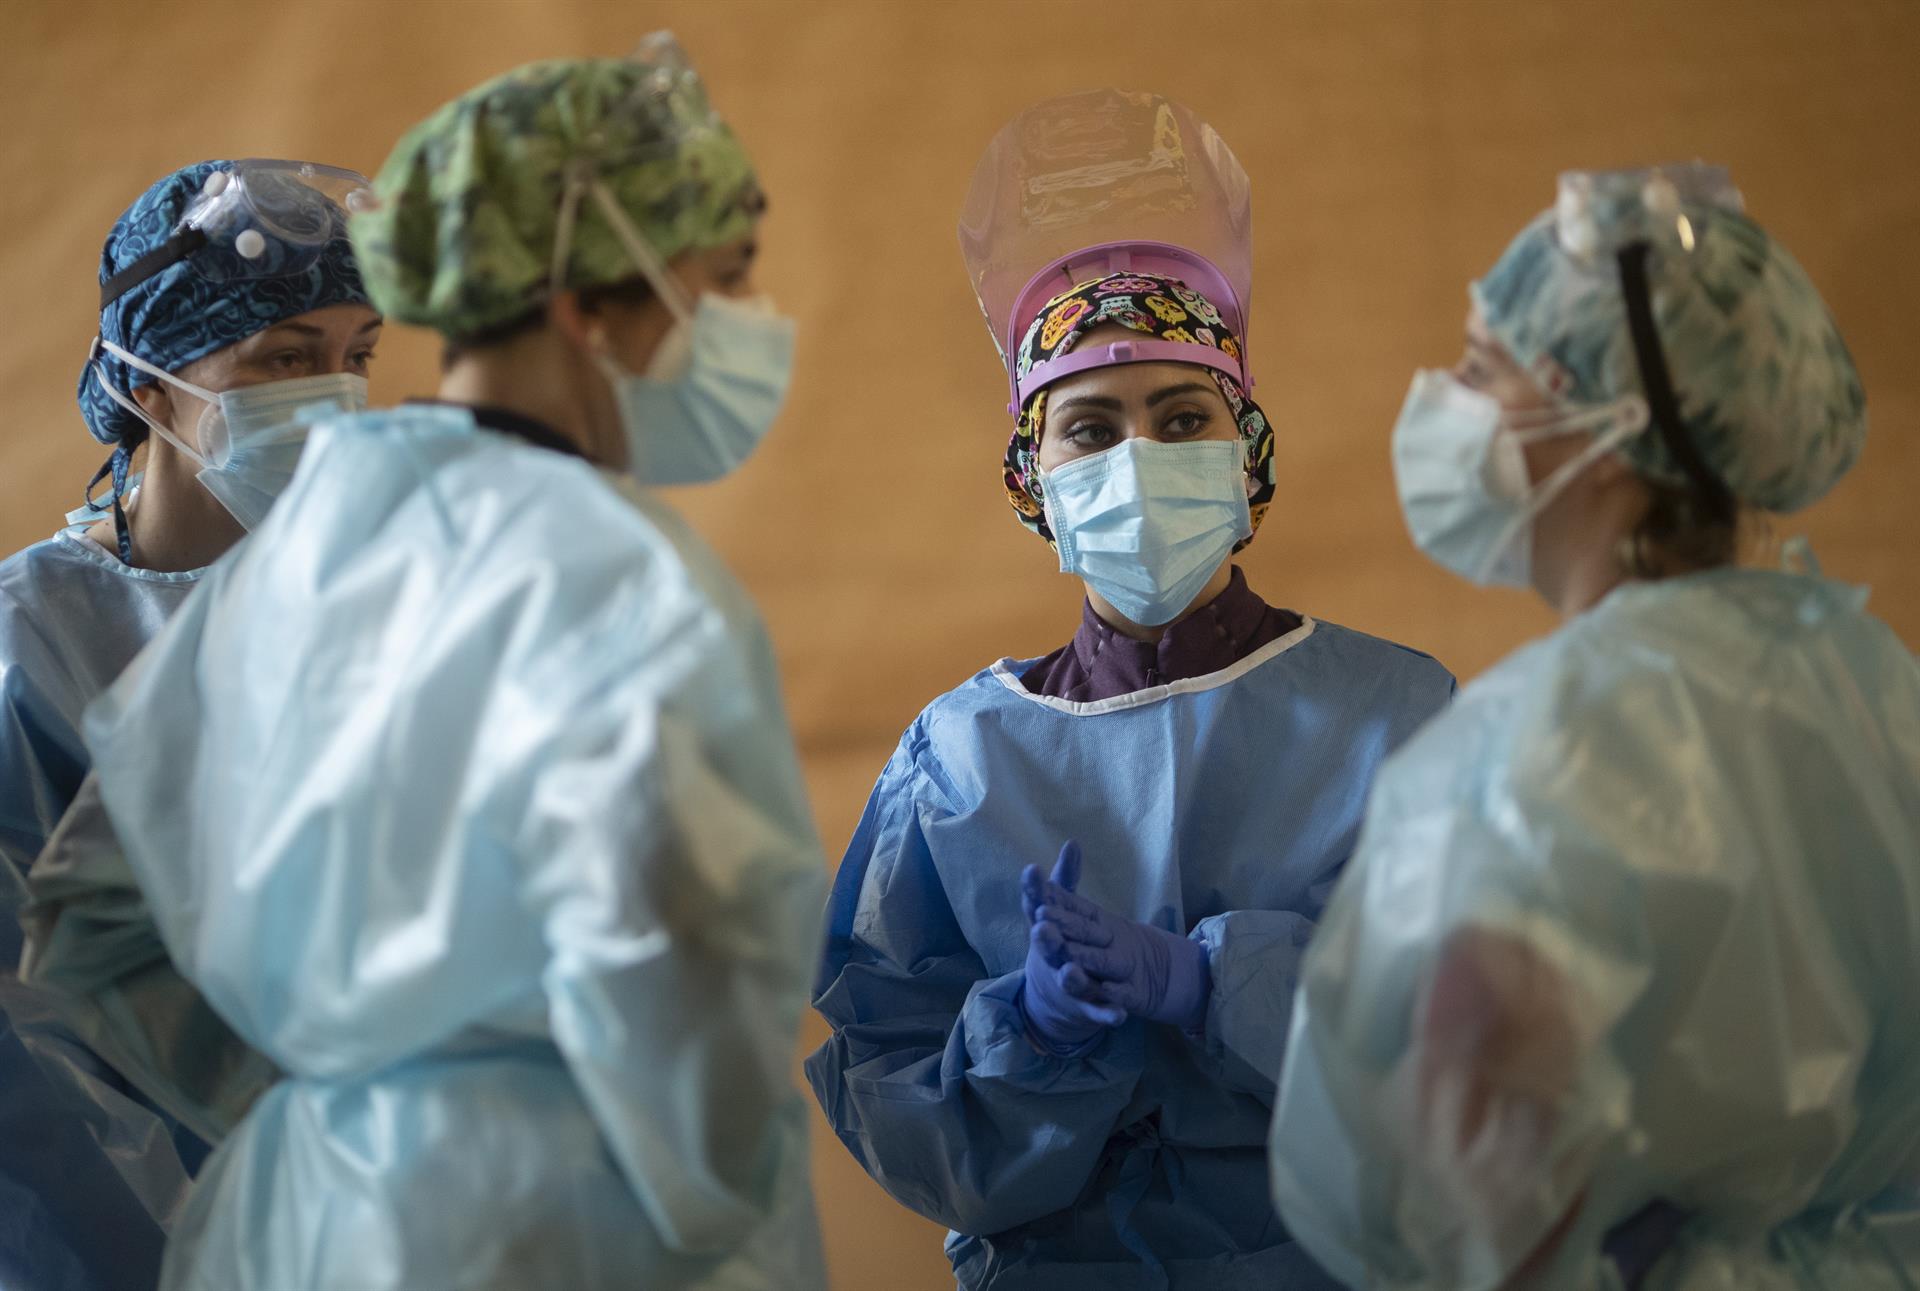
[100,158,374,309]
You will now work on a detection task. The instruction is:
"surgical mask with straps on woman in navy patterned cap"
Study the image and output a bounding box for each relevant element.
[94,340,367,528]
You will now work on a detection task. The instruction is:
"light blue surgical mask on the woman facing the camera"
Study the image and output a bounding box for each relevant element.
[1041,440,1254,626]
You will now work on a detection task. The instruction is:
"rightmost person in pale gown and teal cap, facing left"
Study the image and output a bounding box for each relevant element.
[1273,165,1920,1291]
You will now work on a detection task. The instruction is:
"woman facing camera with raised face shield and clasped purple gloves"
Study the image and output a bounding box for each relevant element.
[806,90,1453,1291]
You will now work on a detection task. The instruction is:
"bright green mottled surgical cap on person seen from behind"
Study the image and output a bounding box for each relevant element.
[351,33,764,338]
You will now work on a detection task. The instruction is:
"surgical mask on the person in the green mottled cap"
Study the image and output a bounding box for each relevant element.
[599,292,793,484]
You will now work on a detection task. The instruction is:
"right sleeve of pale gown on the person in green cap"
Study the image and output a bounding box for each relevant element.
[515,587,826,1254]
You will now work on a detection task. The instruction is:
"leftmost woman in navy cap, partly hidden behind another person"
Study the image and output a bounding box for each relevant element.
[0,161,380,1289]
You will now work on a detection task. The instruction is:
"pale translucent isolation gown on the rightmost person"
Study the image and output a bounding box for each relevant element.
[1273,571,1920,1291]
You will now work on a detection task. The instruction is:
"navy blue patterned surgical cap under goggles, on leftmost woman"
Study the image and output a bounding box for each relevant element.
[79,161,371,444]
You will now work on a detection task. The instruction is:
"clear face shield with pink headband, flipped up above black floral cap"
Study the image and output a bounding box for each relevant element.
[960,88,1254,409]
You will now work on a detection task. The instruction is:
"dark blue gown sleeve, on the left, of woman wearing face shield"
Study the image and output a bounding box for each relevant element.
[806,728,1144,1235]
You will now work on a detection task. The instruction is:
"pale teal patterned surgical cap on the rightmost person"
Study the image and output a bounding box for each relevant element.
[1473,163,1866,511]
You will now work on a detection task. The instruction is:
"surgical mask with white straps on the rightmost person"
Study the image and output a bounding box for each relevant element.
[1394,369,1647,588]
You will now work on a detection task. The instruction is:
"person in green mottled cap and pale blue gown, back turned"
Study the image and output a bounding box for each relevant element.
[31,37,824,1291]
